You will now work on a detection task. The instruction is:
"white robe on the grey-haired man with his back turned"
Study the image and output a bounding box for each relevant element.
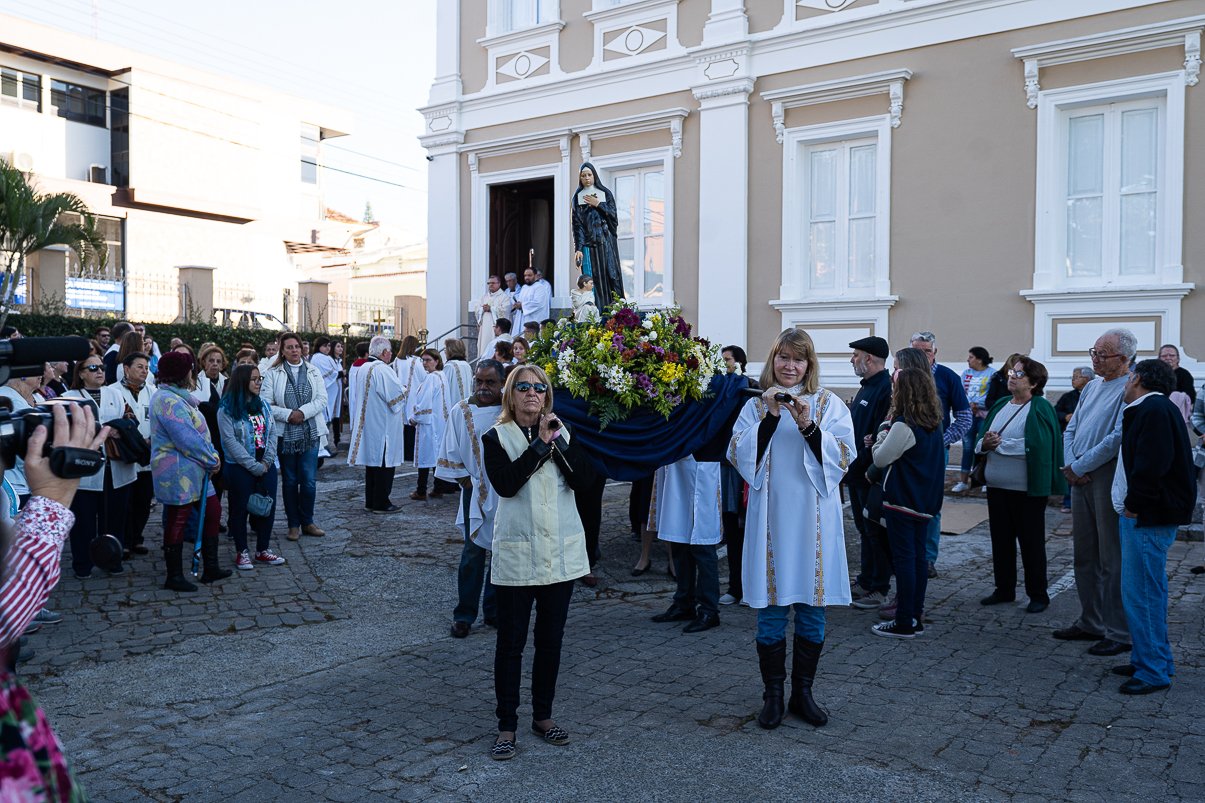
[347,359,405,468]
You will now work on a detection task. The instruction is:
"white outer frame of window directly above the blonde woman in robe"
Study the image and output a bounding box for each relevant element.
[780,115,892,300]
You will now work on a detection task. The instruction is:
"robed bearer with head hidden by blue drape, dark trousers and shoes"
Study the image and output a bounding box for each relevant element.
[648,455,723,633]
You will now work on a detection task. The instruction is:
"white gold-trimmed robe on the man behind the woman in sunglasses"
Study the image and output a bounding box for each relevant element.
[435,399,502,550]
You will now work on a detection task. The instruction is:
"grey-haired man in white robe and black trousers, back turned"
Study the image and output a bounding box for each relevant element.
[347,335,406,514]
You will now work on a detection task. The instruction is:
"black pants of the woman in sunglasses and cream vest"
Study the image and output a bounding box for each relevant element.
[494,580,574,732]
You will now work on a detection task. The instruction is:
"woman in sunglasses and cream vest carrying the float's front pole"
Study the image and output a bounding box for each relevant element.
[481,365,594,761]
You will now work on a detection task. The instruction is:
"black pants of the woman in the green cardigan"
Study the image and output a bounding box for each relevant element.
[987,486,1050,603]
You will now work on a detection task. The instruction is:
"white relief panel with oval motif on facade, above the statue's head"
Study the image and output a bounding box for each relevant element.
[582,0,686,70]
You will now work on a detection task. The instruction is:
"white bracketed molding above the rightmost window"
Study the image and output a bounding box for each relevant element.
[1012,16,1205,109]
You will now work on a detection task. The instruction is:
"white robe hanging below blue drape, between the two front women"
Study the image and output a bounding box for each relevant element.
[649,455,724,545]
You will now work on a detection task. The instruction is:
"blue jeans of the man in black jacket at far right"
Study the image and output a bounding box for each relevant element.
[1118,516,1176,686]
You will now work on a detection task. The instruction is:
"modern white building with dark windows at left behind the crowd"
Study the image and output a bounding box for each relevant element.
[0,16,351,321]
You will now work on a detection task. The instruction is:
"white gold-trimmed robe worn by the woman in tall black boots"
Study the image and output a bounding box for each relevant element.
[728,388,857,608]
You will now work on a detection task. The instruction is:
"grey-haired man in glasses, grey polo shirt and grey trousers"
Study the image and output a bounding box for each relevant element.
[1053,329,1137,655]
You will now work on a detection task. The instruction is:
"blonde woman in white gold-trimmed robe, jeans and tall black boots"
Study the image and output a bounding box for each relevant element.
[728,329,857,728]
